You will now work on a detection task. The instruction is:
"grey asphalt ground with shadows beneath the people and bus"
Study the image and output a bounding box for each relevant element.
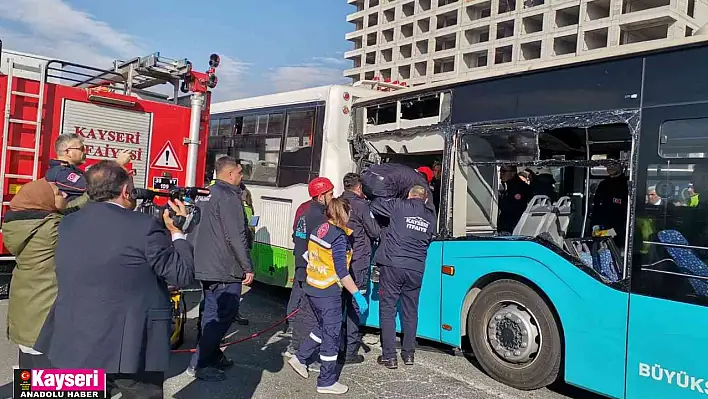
[0,285,596,399]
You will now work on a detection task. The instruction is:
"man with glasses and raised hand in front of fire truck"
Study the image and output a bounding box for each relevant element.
[44,133,131,210]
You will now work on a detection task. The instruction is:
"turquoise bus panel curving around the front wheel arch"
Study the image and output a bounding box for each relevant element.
[440,240,628,398]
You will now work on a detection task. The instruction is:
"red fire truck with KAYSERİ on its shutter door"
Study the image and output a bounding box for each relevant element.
[0,42,219,295]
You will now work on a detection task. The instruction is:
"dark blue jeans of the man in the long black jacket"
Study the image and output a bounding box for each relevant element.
[189,281,242,369]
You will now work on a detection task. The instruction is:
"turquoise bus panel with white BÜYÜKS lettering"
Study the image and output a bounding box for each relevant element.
[627,294,708,399]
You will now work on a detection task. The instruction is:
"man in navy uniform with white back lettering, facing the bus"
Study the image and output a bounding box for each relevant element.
[371,185,435,368]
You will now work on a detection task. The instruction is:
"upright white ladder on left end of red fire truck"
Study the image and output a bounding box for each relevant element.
[0,58,45,214]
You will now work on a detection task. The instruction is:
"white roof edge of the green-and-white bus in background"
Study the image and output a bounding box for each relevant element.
[210,85,351,114]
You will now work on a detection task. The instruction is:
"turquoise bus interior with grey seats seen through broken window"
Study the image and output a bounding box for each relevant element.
[452,123,632,283]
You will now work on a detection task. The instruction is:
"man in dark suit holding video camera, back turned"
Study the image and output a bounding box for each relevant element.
[36,160,194,399]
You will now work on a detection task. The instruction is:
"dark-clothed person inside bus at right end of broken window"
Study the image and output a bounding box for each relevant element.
[592,165,629,248]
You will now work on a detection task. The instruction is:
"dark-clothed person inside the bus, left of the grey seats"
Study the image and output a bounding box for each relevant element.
[497,166,533,234]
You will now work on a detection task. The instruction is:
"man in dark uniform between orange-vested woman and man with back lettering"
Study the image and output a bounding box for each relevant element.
[341,173,381,364]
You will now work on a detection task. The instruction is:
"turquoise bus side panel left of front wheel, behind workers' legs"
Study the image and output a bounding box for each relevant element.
[363,241,443,342]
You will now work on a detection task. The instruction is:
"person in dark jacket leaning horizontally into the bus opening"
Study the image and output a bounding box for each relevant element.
[361,162,435,211]
